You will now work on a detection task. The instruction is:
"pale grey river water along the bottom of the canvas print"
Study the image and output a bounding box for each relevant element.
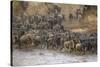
[12,49,97,66]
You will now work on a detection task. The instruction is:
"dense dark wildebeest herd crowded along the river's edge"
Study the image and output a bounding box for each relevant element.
[12,4,97,52]
